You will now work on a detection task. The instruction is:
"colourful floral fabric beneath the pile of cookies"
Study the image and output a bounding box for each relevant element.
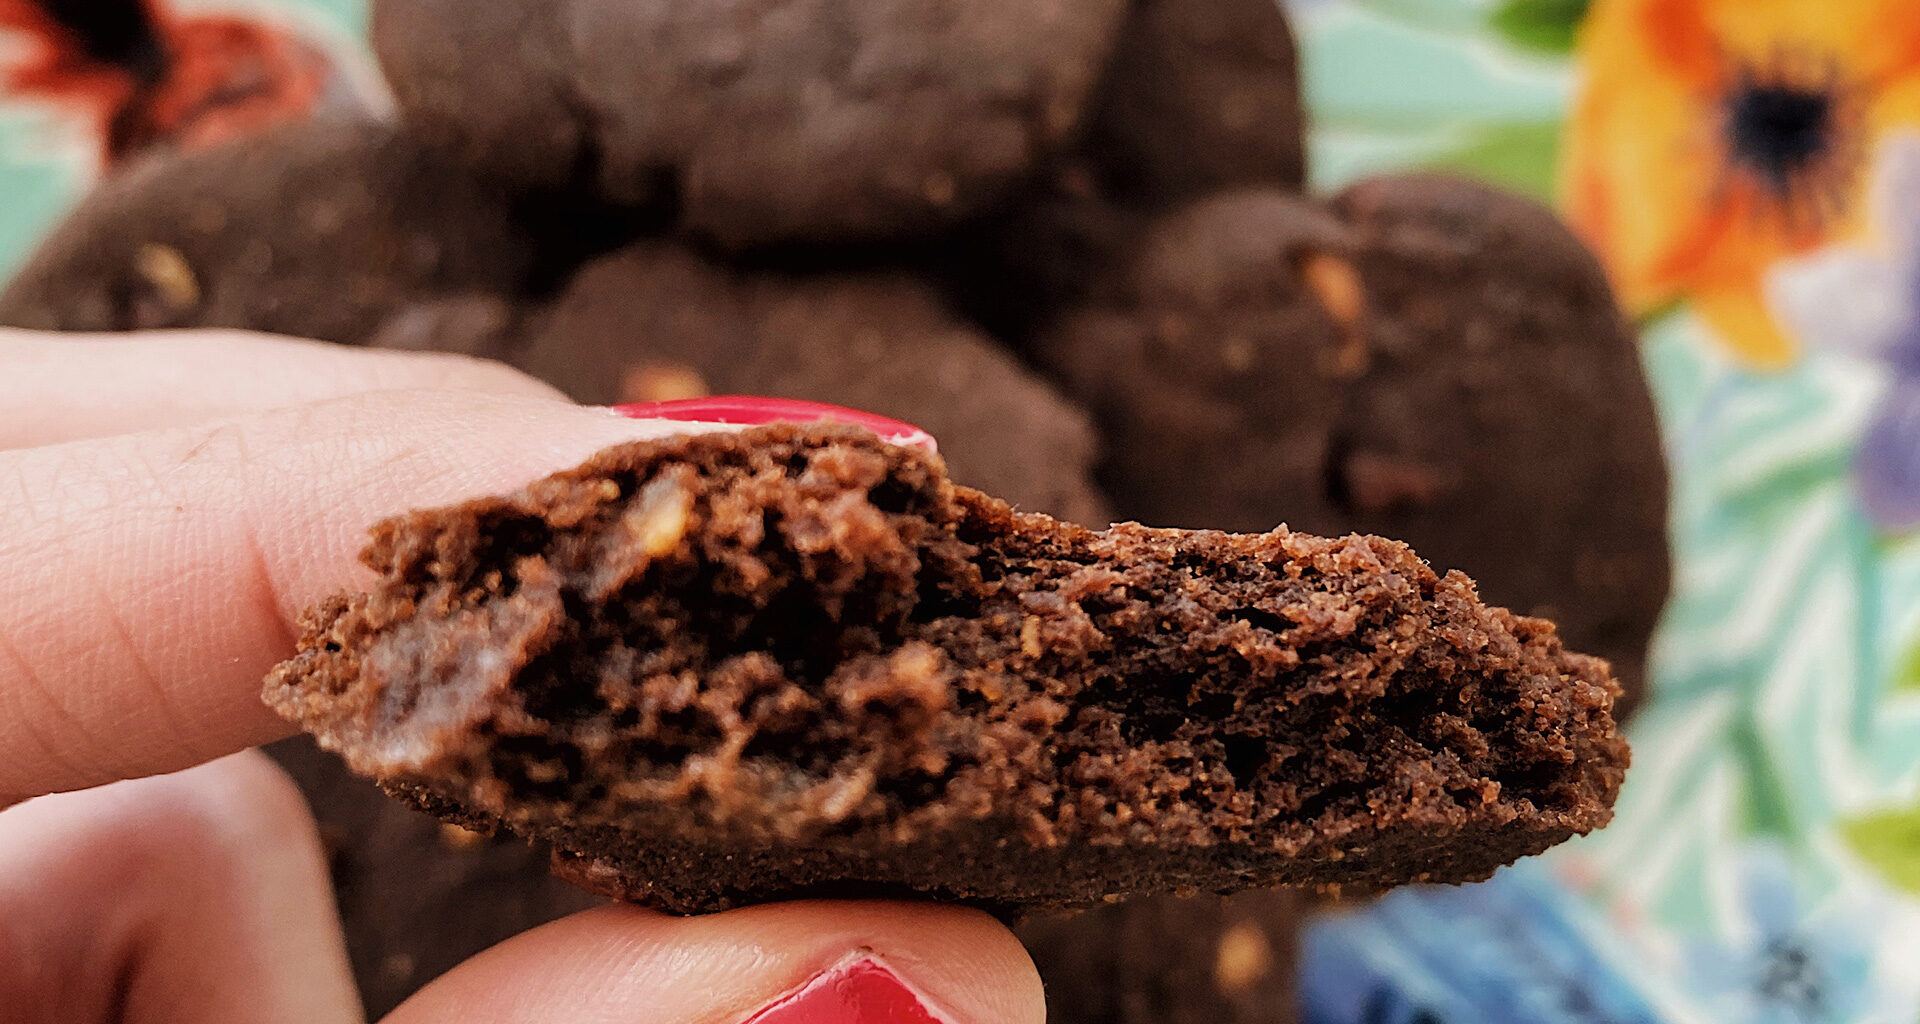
[11,0,1920,1024]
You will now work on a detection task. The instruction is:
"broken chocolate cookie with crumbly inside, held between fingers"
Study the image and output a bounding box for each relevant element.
[265,425,1626,913]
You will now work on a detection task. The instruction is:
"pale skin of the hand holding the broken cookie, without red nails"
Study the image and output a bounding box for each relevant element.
[0,330,1044,1024]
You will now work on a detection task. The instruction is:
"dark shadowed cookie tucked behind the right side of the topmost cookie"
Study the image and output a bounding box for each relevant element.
[941,0,1306,342]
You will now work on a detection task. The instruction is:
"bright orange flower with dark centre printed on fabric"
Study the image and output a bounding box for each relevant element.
[1561,0,1920,367]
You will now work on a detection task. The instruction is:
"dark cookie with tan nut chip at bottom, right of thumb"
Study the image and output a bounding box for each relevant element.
[1020,891,1306,1024]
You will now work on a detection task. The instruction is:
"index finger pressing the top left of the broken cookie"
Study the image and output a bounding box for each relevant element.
[0,392,721,807]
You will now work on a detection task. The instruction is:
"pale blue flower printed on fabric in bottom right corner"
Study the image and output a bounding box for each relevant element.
[1690,845,1874,1024]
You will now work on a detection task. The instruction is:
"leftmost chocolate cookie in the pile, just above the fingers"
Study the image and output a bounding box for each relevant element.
[0,121,536,342]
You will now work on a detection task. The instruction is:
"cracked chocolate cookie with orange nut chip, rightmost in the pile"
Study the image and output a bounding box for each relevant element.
[1035,177,1668,710]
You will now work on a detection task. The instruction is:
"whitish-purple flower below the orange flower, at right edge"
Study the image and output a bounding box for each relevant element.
[1768,133,1920,532]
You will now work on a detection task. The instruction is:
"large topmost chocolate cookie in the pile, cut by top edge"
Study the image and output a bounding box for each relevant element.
[372,0,1125,248]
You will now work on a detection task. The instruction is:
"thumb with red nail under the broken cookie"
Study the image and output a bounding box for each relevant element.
[386,901,1046,1024]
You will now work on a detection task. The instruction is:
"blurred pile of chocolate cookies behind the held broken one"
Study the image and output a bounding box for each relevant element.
[0,0,1668,1024]
